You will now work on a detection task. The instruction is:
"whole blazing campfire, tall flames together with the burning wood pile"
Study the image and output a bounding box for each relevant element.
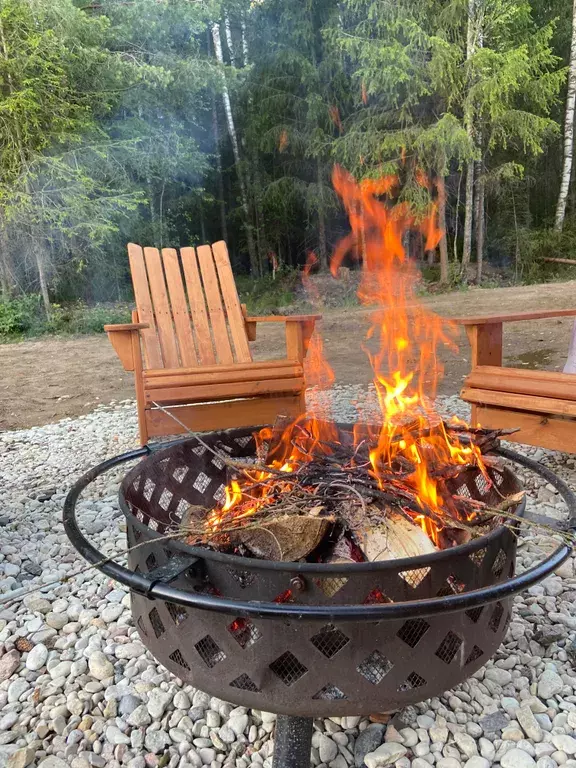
[183,167,519,562]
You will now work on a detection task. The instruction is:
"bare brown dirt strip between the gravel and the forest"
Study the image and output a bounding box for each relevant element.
[0,281,576,429]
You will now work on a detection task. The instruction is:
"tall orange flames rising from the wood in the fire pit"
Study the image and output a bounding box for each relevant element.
[207,167,487,543]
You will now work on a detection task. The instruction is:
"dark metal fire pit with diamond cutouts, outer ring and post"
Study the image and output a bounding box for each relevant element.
[64,425,576,768]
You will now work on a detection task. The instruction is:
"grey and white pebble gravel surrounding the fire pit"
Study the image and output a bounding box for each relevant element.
[0,387,576,768]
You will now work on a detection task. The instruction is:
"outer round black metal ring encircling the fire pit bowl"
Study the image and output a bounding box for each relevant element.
[63,444,576,621]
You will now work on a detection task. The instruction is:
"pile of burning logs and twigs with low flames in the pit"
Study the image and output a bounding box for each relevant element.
[181,419,520,562]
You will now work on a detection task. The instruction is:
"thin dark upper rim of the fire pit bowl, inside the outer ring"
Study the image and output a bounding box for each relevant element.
[118,432,526,576]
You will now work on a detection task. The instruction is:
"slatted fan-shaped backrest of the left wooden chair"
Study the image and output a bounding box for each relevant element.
[128,241,252,369]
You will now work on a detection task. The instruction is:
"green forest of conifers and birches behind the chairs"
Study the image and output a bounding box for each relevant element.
[0,0,576,339]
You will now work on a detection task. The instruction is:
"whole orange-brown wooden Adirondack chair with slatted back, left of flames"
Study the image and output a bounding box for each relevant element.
[104,242,320,445]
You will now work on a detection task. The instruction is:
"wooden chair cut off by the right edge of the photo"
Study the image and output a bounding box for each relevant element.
[456,309,576,453]
